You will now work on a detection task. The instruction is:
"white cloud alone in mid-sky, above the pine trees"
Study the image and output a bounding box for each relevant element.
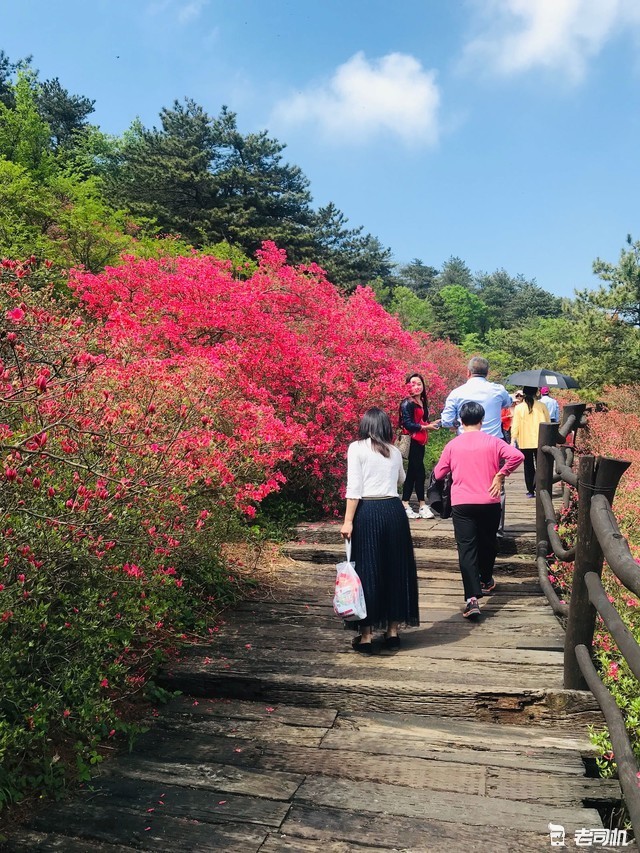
[272,52,440,145]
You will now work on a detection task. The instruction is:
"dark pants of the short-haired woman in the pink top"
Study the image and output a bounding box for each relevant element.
[452,503,500,599]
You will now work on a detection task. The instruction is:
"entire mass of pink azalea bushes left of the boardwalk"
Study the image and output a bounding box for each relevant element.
[0,244,463,806]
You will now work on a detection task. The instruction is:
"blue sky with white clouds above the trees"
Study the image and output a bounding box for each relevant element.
[0,0,640,296]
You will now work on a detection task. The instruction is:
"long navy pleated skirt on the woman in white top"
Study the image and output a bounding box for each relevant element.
[345,498,420,631]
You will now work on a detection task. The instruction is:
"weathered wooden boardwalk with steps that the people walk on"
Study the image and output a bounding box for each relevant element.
[7,475,635,853]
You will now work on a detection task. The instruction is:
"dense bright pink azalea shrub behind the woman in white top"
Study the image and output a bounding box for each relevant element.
[71,243,464,513]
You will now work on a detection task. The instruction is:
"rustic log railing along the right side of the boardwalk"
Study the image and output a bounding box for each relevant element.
[536,404,640,838]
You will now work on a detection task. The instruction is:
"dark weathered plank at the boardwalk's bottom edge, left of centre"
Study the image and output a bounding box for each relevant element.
[25,803,267,853]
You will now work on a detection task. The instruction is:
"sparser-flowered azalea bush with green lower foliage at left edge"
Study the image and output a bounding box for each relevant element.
[0,262,268,805]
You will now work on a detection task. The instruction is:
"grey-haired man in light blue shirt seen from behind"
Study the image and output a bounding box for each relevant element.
[440,355,513,537]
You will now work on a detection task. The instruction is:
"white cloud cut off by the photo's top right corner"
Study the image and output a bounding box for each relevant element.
[465,0,640,83]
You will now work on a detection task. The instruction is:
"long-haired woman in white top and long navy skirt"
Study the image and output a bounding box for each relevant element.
[340,408,420,654]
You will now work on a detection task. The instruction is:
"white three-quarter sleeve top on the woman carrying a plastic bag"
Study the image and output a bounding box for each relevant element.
[346,438,405,500]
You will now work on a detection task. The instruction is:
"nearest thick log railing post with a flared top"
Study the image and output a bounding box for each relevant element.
[564,456,629,690]
